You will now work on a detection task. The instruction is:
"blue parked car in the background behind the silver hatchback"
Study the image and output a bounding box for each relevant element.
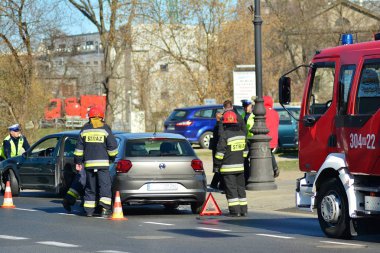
[164,105,244,148]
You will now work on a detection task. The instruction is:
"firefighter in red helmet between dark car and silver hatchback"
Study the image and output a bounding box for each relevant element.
[74,106,118,218]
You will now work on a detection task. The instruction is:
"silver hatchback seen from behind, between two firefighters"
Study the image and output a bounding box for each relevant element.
[111,133,207,213]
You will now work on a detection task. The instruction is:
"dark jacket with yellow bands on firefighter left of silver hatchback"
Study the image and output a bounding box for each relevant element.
[74,123,118,169]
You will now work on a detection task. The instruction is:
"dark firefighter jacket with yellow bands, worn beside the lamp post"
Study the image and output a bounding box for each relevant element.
[215,124,248,174]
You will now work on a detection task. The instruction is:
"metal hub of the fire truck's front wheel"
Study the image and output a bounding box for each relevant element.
[321,194,342,223]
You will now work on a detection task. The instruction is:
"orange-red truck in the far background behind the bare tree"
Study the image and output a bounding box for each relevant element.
[41,95,106,128]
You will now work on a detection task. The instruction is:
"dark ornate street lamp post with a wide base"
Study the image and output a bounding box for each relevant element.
[247,0,277,191]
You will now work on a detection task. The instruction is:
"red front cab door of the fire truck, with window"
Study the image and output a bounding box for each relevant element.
[299,58,339,171]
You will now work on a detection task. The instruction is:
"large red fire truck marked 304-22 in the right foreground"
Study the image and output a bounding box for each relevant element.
[279,34,380,238]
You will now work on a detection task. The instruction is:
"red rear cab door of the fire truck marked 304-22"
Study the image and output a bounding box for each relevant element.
[336,58,380,175]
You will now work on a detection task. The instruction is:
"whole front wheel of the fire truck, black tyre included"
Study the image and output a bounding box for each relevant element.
[317,178,351,239]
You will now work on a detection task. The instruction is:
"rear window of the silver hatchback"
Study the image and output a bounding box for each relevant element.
[126,138,195,157]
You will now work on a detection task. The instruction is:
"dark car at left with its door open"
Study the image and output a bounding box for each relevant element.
[0,131,79,196]
